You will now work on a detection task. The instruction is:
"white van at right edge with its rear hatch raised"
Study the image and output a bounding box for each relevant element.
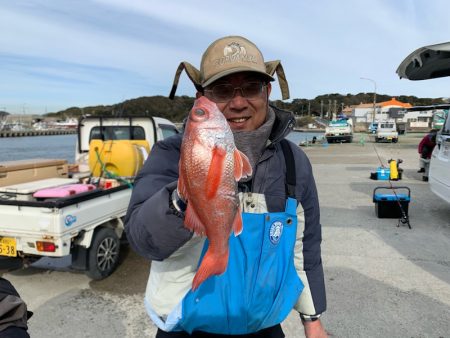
[397,42,450,203]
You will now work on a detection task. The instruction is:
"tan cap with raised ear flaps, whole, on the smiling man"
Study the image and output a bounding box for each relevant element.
[169,36,289,100]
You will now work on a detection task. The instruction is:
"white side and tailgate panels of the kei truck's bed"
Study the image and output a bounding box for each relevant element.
[0,185,131,257]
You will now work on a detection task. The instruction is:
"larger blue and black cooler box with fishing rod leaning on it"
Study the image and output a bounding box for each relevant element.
[373,187,411,218]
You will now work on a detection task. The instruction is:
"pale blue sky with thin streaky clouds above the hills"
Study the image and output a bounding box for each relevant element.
[0,0,450,114]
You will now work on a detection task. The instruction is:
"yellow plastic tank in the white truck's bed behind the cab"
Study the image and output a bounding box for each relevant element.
[89,140,150,177]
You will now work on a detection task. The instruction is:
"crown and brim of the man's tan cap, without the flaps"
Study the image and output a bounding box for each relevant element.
[200,36,274,88]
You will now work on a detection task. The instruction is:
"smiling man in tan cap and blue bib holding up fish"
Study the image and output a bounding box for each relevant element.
[125,36,326,337]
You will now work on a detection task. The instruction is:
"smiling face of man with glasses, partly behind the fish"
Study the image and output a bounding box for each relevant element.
[204,72,271,131]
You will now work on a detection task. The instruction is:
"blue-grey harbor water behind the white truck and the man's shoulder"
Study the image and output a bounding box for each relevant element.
[0,131,323,163]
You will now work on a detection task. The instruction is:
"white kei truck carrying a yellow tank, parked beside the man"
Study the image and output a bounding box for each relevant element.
[0,116,178,280]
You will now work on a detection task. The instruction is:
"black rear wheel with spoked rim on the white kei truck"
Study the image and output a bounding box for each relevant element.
[86,228,120,280]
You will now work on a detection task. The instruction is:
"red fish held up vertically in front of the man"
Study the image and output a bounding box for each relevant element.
[178,96,252,290]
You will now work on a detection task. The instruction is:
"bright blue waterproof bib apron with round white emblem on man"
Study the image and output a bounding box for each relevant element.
[174,197,303,334]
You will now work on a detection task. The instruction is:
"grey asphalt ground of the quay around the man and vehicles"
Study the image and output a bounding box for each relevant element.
[3,134,450,338]
